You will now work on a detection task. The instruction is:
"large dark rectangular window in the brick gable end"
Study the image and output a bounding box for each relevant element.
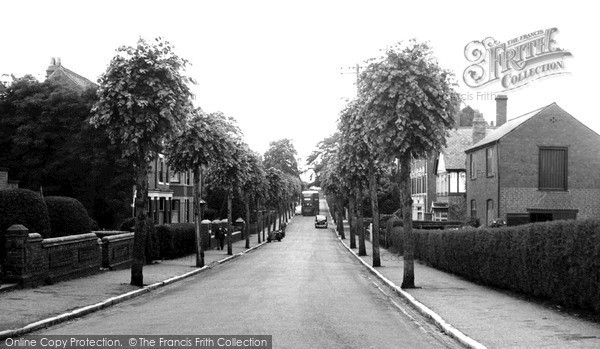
[539,148,568,190]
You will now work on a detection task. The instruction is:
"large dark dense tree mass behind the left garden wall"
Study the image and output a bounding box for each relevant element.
[0,76,134,229]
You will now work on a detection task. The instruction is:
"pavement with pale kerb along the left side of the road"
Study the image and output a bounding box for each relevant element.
[0,230,264,339]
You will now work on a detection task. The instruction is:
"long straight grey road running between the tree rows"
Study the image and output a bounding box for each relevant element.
[36,200,460,349]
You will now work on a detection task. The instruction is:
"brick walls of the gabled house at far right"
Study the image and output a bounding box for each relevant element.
[467,105,600,223]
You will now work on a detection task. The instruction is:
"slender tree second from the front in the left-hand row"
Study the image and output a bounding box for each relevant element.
[166,109,233,267]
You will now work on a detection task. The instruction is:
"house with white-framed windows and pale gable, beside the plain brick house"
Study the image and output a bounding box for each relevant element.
[411,102,502,221]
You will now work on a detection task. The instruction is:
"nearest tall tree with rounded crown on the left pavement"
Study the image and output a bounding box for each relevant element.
[90,38,194,286]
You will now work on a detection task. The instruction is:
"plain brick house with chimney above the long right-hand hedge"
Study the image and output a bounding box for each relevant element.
[465,98,600,225]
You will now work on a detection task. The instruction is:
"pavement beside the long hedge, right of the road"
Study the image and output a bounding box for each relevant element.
[331,222,600,348]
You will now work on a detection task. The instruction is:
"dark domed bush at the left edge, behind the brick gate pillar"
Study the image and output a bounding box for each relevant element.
[0,189,51,237]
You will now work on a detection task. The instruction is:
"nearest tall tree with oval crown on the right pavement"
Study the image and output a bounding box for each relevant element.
[359,41,459,288]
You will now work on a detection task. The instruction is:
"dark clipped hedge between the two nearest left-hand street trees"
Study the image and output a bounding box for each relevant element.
[156,223,196,258]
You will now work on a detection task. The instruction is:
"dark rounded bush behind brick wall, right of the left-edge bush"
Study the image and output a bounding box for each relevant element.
[44,196,92,237]
